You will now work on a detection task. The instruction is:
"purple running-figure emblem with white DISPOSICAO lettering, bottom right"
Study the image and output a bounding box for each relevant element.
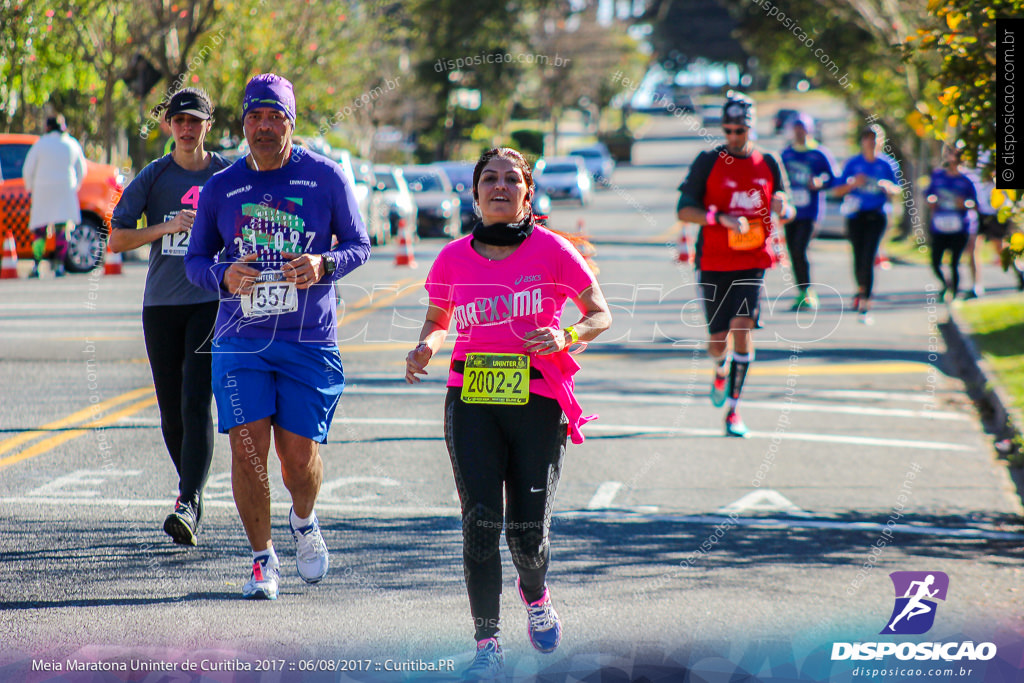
[831,571,996,661]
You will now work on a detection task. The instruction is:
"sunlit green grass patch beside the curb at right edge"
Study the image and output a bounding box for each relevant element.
[961,294,1024,413]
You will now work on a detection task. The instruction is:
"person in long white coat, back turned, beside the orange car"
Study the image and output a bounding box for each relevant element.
[24,115,85,278]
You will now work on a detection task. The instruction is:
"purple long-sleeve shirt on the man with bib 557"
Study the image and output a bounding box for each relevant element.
[184,147,370,343]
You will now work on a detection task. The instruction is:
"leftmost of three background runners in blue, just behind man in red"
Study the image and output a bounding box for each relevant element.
[782,113,836,310]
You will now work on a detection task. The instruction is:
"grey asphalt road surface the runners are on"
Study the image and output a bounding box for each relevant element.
[0,112,1024,681]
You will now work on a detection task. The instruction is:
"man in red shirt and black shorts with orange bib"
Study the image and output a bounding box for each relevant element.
[677,90,794,437]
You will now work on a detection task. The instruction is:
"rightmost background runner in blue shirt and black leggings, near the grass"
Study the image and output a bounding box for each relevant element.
[925,145,978,301]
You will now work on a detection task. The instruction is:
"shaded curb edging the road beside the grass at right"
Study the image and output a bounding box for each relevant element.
[939,304,1024,471]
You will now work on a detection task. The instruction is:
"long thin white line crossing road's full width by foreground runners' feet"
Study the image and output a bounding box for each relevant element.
[0,496,1024,541]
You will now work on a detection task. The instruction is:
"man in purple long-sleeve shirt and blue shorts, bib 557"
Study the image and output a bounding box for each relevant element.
[184,74,370,600]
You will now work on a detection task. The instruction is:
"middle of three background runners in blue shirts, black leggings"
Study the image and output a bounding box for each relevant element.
[835,124,902,325]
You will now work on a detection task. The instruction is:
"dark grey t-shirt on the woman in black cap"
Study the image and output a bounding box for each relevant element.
[111,154,230,306]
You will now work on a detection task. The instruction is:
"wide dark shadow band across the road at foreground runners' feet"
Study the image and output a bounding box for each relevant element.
[0,511,1024,610]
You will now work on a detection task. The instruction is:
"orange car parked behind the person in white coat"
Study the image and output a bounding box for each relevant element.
[0,133,124,272]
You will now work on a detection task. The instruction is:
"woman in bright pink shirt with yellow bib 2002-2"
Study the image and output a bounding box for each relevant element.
[406,147,611,679]
